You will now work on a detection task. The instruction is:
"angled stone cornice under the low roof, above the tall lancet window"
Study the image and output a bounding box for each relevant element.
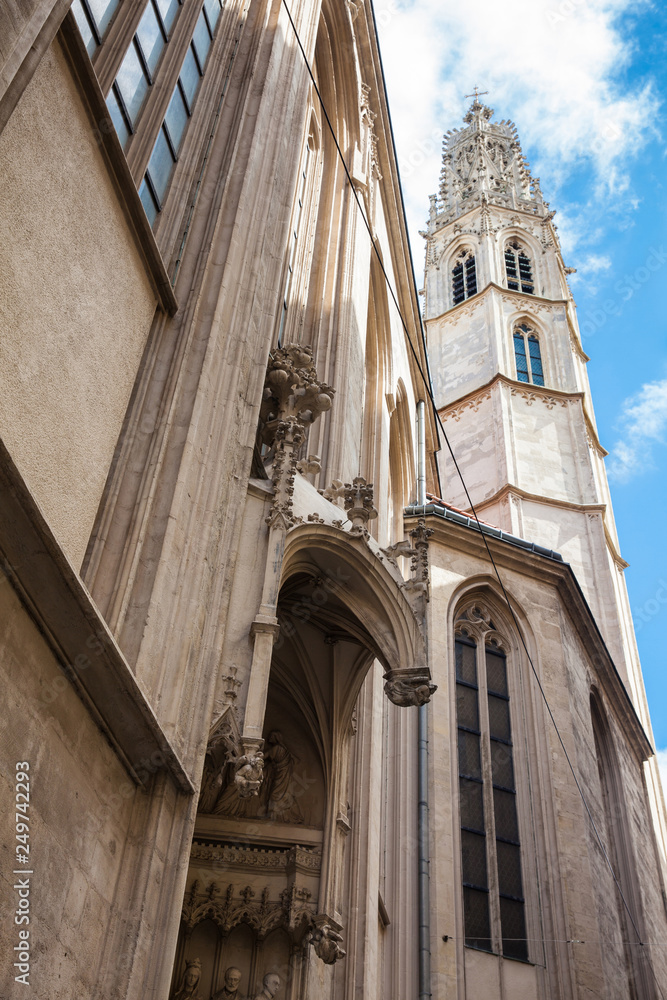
[406,504,654,762]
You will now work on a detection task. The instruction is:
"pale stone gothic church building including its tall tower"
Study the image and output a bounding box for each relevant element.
[0,0,667,1000]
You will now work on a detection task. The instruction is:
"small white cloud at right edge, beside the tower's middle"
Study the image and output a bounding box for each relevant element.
[607,379,667,483]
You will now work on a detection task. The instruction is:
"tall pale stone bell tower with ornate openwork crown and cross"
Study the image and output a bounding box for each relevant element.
[423,91,648,726]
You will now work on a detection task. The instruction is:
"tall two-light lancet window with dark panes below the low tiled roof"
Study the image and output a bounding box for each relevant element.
[455,606,528,959]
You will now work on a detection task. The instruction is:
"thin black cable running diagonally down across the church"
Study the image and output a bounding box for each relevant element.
[282,0,665,988]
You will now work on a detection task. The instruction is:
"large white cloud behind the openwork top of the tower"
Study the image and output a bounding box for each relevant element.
[376,0,658,276]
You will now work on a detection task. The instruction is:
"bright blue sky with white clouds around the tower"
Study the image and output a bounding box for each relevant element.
[375,0,667,775]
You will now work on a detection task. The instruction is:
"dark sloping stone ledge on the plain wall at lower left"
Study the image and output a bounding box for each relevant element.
[0,441,194,795]
